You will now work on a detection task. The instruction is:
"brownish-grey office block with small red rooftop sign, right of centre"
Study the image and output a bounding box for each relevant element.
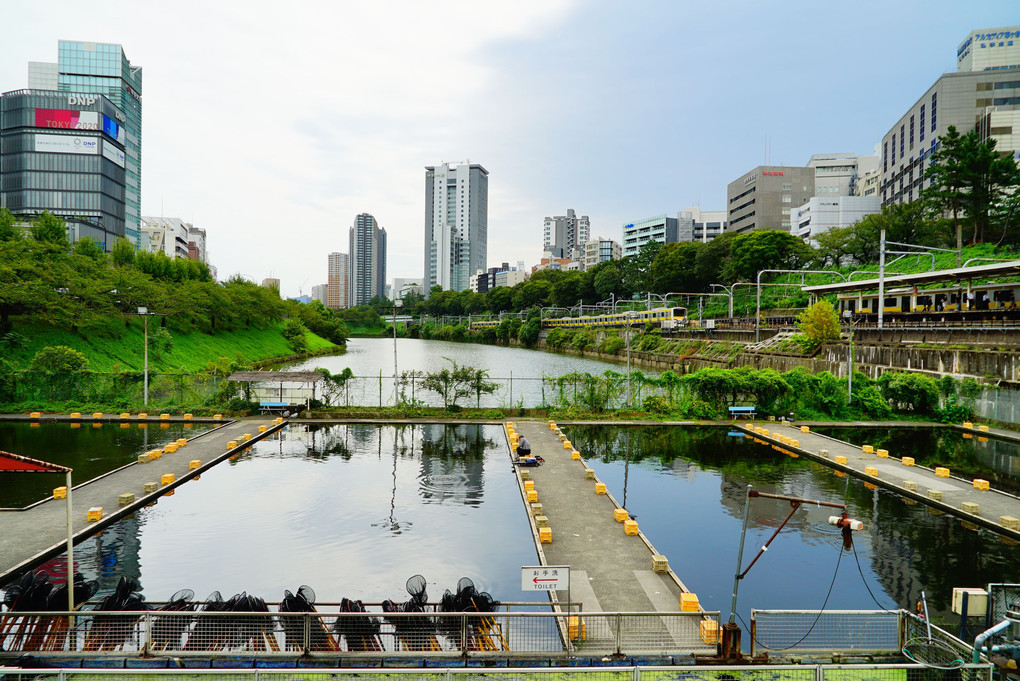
[726,165,815,233]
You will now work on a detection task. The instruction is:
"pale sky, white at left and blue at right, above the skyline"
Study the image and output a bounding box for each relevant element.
[0,0,1020,297]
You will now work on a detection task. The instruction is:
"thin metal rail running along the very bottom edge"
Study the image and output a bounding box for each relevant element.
[0,665,991,681]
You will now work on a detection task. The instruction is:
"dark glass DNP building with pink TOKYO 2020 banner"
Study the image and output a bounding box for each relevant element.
[0,90,127,251]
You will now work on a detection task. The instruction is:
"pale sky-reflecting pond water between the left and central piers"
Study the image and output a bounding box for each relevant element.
[19,424,537,603]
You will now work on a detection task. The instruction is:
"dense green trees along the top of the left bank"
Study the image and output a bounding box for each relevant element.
[0,208,347,345]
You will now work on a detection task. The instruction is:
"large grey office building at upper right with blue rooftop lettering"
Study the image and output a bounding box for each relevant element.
[880,25,1020,206]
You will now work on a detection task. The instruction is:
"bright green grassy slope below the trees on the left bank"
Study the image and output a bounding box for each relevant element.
[3,320,335,372]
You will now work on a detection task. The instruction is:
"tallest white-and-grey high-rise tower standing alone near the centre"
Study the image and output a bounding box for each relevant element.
[424,163,489,291]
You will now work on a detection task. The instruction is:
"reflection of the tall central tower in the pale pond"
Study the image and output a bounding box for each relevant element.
[418,424,491,506]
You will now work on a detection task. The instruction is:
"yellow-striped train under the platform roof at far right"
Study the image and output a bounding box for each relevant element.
[837,281,1020,317]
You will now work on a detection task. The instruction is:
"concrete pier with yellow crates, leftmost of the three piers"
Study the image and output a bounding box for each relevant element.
[0,417,286,583]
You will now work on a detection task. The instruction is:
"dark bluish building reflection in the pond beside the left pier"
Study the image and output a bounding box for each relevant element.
[36,514,141,597]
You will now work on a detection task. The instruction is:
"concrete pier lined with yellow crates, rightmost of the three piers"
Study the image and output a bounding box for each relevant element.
[732,422,1020,540]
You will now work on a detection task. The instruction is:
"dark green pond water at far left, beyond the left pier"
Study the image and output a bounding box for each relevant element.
[0,421,209,508]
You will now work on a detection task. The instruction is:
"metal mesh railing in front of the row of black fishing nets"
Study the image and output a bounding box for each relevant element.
[0,611,719,659]
